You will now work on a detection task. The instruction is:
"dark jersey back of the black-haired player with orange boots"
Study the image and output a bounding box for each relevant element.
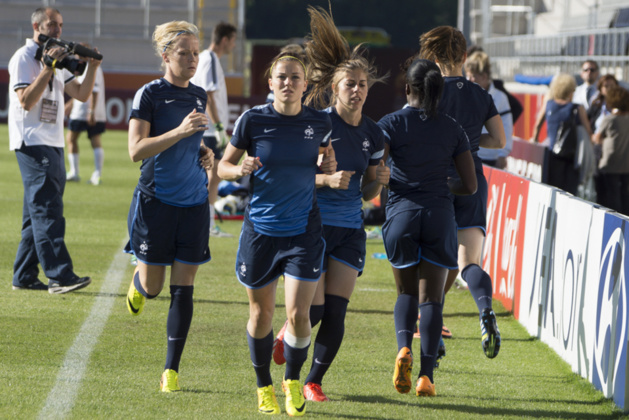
[378,107,470,217]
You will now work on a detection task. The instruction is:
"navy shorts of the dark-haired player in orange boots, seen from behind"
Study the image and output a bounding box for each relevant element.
[382,203,458,270]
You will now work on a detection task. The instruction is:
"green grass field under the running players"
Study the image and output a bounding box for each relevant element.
[0,126,623,419]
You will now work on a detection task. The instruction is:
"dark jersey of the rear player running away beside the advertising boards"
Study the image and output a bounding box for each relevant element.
[439,77,498,171]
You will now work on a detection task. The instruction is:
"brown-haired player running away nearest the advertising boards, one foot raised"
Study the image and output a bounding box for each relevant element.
[419,26,506,358]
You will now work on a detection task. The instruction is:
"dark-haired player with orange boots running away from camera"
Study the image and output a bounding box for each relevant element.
[378,59,477,396]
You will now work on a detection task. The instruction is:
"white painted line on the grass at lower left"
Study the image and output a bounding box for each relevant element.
[39,239,129,419]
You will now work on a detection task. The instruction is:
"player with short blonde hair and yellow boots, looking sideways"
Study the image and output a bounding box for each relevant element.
[125,21,214,392]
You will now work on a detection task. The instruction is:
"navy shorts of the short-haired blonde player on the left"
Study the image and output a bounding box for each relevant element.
[125,189,211,265]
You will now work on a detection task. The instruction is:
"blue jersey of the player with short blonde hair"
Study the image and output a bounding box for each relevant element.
[131,78,208,207]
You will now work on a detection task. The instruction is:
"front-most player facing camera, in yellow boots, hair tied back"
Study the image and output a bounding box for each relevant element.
[218,55,336,416]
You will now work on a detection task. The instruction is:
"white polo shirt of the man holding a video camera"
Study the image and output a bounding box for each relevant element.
[9,38,74,150]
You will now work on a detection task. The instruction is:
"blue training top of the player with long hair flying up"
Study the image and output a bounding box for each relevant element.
[317,107,384,229]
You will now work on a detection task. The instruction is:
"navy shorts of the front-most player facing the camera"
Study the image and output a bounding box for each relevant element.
[236,210,325,289]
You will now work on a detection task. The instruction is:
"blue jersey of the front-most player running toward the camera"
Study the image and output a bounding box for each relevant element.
[231,104,332,236]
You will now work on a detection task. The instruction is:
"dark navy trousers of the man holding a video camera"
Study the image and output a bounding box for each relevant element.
[13,146,74,286]
